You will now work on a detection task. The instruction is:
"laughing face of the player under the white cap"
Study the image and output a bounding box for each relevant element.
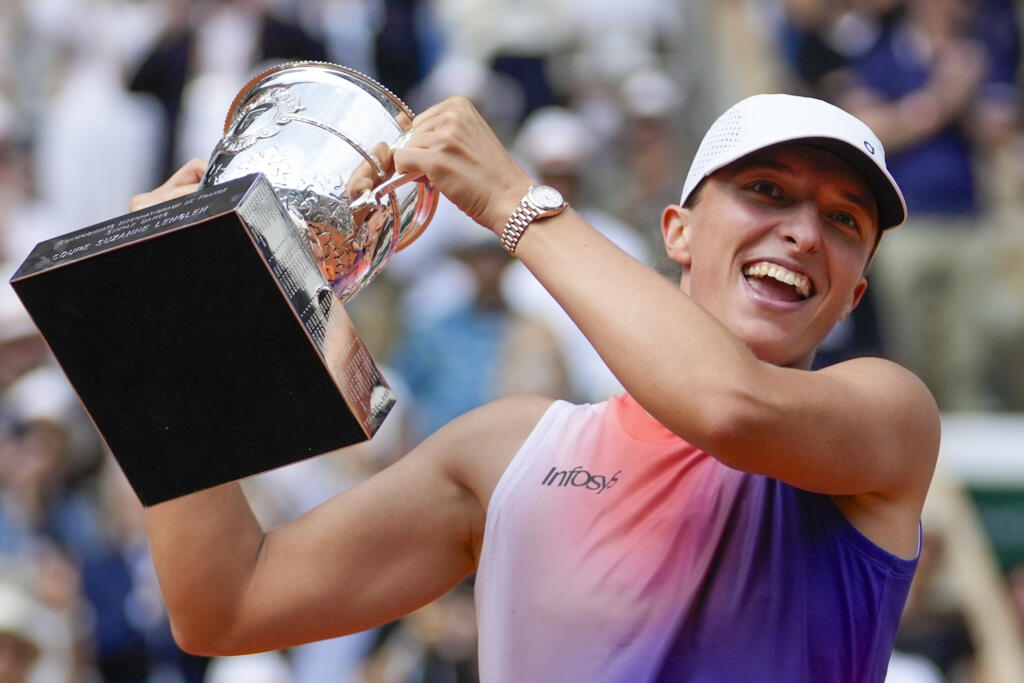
[662,144,878,368]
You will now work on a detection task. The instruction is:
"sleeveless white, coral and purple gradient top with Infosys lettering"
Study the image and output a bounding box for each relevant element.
[475,395,916,683]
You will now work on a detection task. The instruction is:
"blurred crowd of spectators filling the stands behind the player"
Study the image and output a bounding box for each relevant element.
[0,0,1024,683]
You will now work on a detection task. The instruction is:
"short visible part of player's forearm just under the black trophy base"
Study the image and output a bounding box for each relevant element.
[145,483,263,652]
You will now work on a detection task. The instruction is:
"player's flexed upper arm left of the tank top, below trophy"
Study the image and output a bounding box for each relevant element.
[238,430,482,651]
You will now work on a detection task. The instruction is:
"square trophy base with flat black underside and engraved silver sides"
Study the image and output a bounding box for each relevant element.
[11,176,394,506]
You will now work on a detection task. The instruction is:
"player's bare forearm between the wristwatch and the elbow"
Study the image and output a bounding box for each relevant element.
[516,211,762,446]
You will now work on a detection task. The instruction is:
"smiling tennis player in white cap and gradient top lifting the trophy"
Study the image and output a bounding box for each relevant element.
[133,94,939,683]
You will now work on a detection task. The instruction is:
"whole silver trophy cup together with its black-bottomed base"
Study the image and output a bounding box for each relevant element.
[11,62,437,505]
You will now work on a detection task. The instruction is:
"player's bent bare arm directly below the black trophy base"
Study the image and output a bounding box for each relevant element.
[146,397,550,654]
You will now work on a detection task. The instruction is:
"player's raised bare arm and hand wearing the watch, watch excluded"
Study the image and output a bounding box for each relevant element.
[396,99,938,501]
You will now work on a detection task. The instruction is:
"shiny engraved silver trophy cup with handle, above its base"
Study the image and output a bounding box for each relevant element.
[201,61,437,301]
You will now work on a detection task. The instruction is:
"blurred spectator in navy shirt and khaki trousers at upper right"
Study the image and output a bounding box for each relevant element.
[835,0,1019,410]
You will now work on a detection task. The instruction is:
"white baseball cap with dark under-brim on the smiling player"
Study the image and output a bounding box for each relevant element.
[679,94,906,229]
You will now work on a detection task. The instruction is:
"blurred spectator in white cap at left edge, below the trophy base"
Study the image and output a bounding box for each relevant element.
[0,374,103,683]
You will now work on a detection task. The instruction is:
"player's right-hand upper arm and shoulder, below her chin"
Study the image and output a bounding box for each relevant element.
[719,358,939,496]
